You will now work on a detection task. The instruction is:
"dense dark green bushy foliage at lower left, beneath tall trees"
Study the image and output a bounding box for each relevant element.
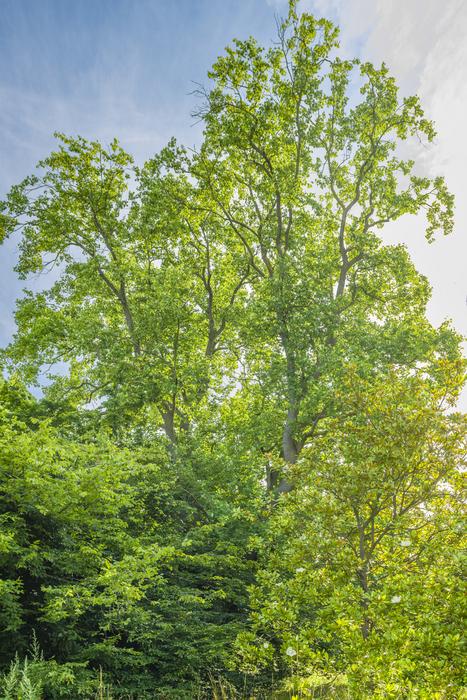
[0,380,258,697]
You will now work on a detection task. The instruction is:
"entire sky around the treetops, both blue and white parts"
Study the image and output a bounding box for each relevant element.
[0,0,467,406]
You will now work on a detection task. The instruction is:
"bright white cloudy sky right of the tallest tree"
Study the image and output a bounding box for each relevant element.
[301,0,467,408]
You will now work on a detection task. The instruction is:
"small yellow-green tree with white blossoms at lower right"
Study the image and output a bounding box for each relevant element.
[240,363,466,698]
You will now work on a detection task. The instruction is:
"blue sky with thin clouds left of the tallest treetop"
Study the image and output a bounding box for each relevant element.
[0,0,282,183]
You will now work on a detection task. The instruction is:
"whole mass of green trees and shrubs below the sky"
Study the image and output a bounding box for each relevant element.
[0,2,466,700]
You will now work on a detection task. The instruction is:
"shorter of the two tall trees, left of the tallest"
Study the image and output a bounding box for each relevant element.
[0,135,246,453]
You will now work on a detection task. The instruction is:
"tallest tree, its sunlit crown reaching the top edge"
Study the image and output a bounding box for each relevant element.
[194,2,453,489]
